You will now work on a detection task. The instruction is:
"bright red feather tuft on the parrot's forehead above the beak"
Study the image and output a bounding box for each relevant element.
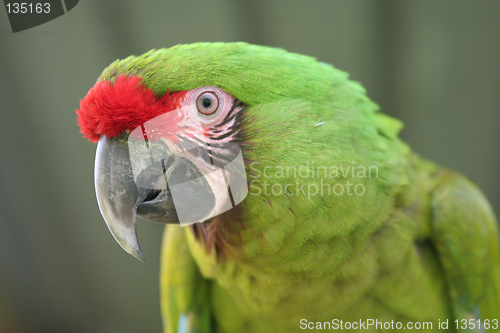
[76,75,186,143]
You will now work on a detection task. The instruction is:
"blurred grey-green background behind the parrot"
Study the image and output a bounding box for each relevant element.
[0,0,500,333]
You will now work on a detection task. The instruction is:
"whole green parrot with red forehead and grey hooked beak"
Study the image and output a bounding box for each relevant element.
[77,42,500,333]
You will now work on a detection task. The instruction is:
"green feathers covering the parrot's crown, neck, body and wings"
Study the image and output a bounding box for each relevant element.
[100,43,500,333]
